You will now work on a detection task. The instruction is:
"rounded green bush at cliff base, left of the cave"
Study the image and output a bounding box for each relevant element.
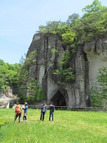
[19,78,46,104]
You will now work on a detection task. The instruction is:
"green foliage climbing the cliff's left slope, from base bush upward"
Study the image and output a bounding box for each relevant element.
[19,51,46,103]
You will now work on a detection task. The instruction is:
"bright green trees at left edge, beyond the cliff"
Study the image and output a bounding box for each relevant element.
[0,60,21,92]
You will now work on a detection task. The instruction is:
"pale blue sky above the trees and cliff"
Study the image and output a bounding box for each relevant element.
[0,0,107,64]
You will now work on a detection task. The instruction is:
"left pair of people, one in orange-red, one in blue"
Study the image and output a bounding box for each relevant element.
[15,102,28,123]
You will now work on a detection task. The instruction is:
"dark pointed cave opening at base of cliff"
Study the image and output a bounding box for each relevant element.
[51,90,66,106]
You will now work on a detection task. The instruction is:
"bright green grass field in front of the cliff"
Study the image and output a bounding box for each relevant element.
[0,109,107,143]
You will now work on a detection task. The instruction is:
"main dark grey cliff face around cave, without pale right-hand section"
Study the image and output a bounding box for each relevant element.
[28,34,89,107]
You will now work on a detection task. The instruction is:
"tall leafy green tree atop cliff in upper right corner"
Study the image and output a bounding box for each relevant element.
[81,0,107,41]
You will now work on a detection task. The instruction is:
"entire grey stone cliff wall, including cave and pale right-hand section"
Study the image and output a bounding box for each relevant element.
[28,33,107,108]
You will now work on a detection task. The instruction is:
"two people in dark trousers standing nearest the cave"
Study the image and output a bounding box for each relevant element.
[40,102,55,121]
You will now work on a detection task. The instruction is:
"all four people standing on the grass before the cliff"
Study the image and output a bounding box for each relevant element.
[15,102,55,123]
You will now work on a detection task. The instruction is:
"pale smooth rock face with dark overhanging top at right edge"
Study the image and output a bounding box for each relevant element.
[84,38,107,89]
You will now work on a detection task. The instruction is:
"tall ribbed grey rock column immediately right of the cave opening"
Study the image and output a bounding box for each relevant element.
[67,47,89,107]
